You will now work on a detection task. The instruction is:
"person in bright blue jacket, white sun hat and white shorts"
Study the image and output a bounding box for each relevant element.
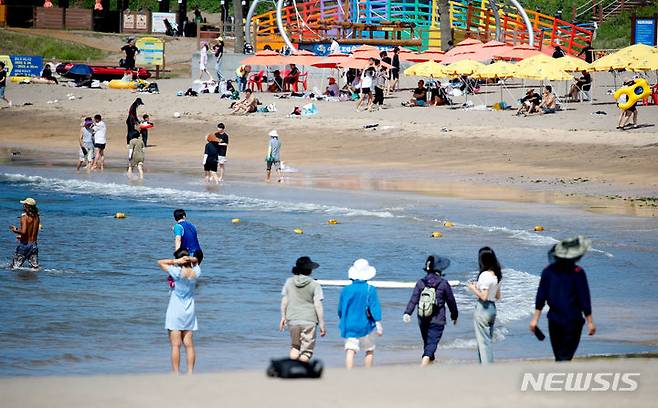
[338,259,384,369]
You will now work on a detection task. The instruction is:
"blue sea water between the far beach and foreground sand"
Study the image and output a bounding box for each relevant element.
[0,166,658,376]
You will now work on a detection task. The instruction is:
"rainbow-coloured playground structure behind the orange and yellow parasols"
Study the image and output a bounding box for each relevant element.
[245,0,593,55]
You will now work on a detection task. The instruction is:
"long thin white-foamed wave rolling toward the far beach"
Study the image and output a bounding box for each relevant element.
[0,173,396,218]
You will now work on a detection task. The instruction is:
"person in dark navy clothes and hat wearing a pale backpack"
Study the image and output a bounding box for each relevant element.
[402,255,459,367]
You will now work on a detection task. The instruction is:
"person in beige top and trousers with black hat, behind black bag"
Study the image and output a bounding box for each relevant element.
[279,256,327,361]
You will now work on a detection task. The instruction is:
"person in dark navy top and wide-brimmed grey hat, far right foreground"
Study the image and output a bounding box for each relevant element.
[530,236,596,361]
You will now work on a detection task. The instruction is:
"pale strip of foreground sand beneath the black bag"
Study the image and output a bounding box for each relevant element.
[0,359,658,408]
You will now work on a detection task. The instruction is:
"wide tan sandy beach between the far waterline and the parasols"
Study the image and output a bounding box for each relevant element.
[0,73,658,216]
